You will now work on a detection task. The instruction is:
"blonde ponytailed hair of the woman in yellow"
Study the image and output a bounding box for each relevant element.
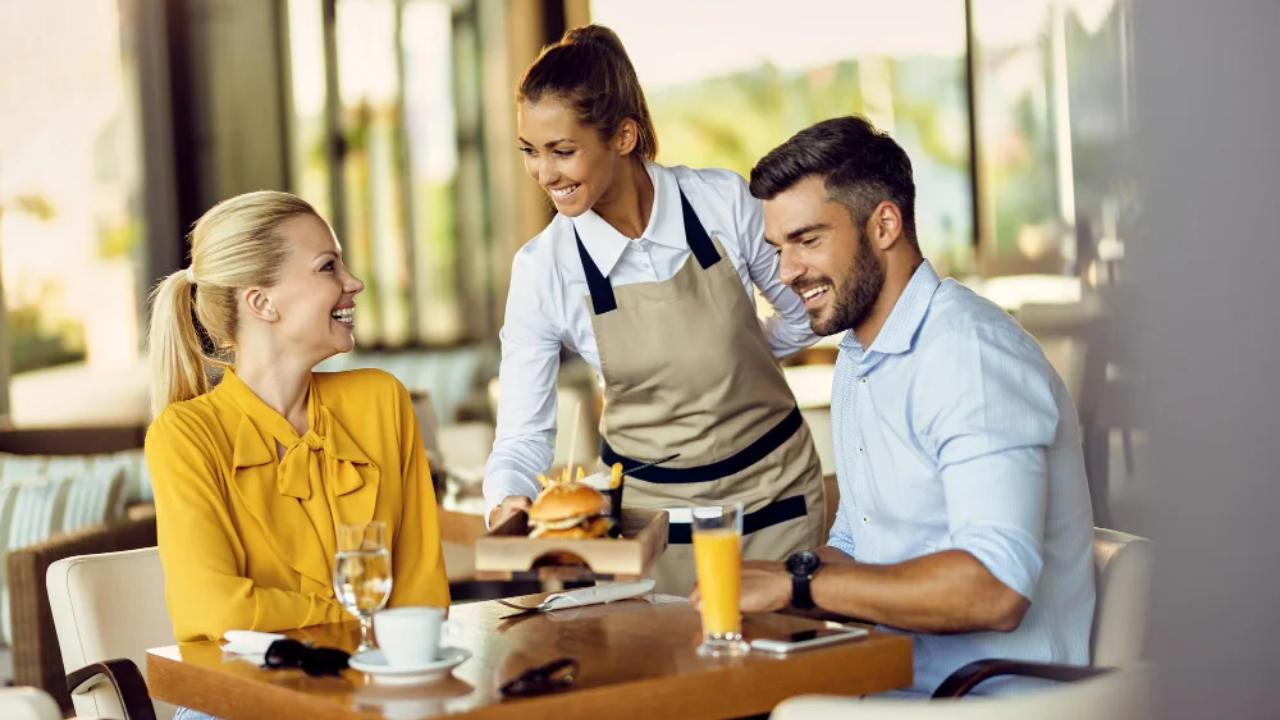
[147,191,320,415]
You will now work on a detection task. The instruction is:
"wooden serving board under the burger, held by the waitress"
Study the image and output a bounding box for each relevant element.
[476,509,667,582]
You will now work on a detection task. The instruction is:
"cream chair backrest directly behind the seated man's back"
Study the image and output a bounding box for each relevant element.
[1092,528,1155,666]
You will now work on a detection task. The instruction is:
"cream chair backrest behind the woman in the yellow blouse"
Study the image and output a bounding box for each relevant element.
[46,547,175,720]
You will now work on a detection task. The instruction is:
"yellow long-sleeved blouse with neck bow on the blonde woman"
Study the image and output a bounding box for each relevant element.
[146,370,449,642]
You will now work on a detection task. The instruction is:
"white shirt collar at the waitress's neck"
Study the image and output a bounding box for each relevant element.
[571,160,689,275]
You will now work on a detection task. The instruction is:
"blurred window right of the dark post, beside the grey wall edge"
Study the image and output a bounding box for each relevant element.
[972,0,1132,275]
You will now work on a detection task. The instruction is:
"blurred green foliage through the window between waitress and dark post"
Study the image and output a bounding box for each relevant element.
[648,58,973,273]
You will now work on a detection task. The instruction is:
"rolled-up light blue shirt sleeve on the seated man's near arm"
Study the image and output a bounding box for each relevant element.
[911,328,1060,598]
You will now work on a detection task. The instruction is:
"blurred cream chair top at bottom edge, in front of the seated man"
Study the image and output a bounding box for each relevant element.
[769,667,1151,720]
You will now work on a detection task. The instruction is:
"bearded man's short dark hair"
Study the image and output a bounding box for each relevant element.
[751,115,919,243]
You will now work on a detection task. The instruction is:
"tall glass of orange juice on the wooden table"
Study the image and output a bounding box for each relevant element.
[692,505,748,656]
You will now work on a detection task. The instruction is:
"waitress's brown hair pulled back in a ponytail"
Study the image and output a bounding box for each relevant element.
[516,24,658,160]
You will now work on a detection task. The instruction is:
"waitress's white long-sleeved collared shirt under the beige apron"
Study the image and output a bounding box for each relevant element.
[484,163,818,507]
